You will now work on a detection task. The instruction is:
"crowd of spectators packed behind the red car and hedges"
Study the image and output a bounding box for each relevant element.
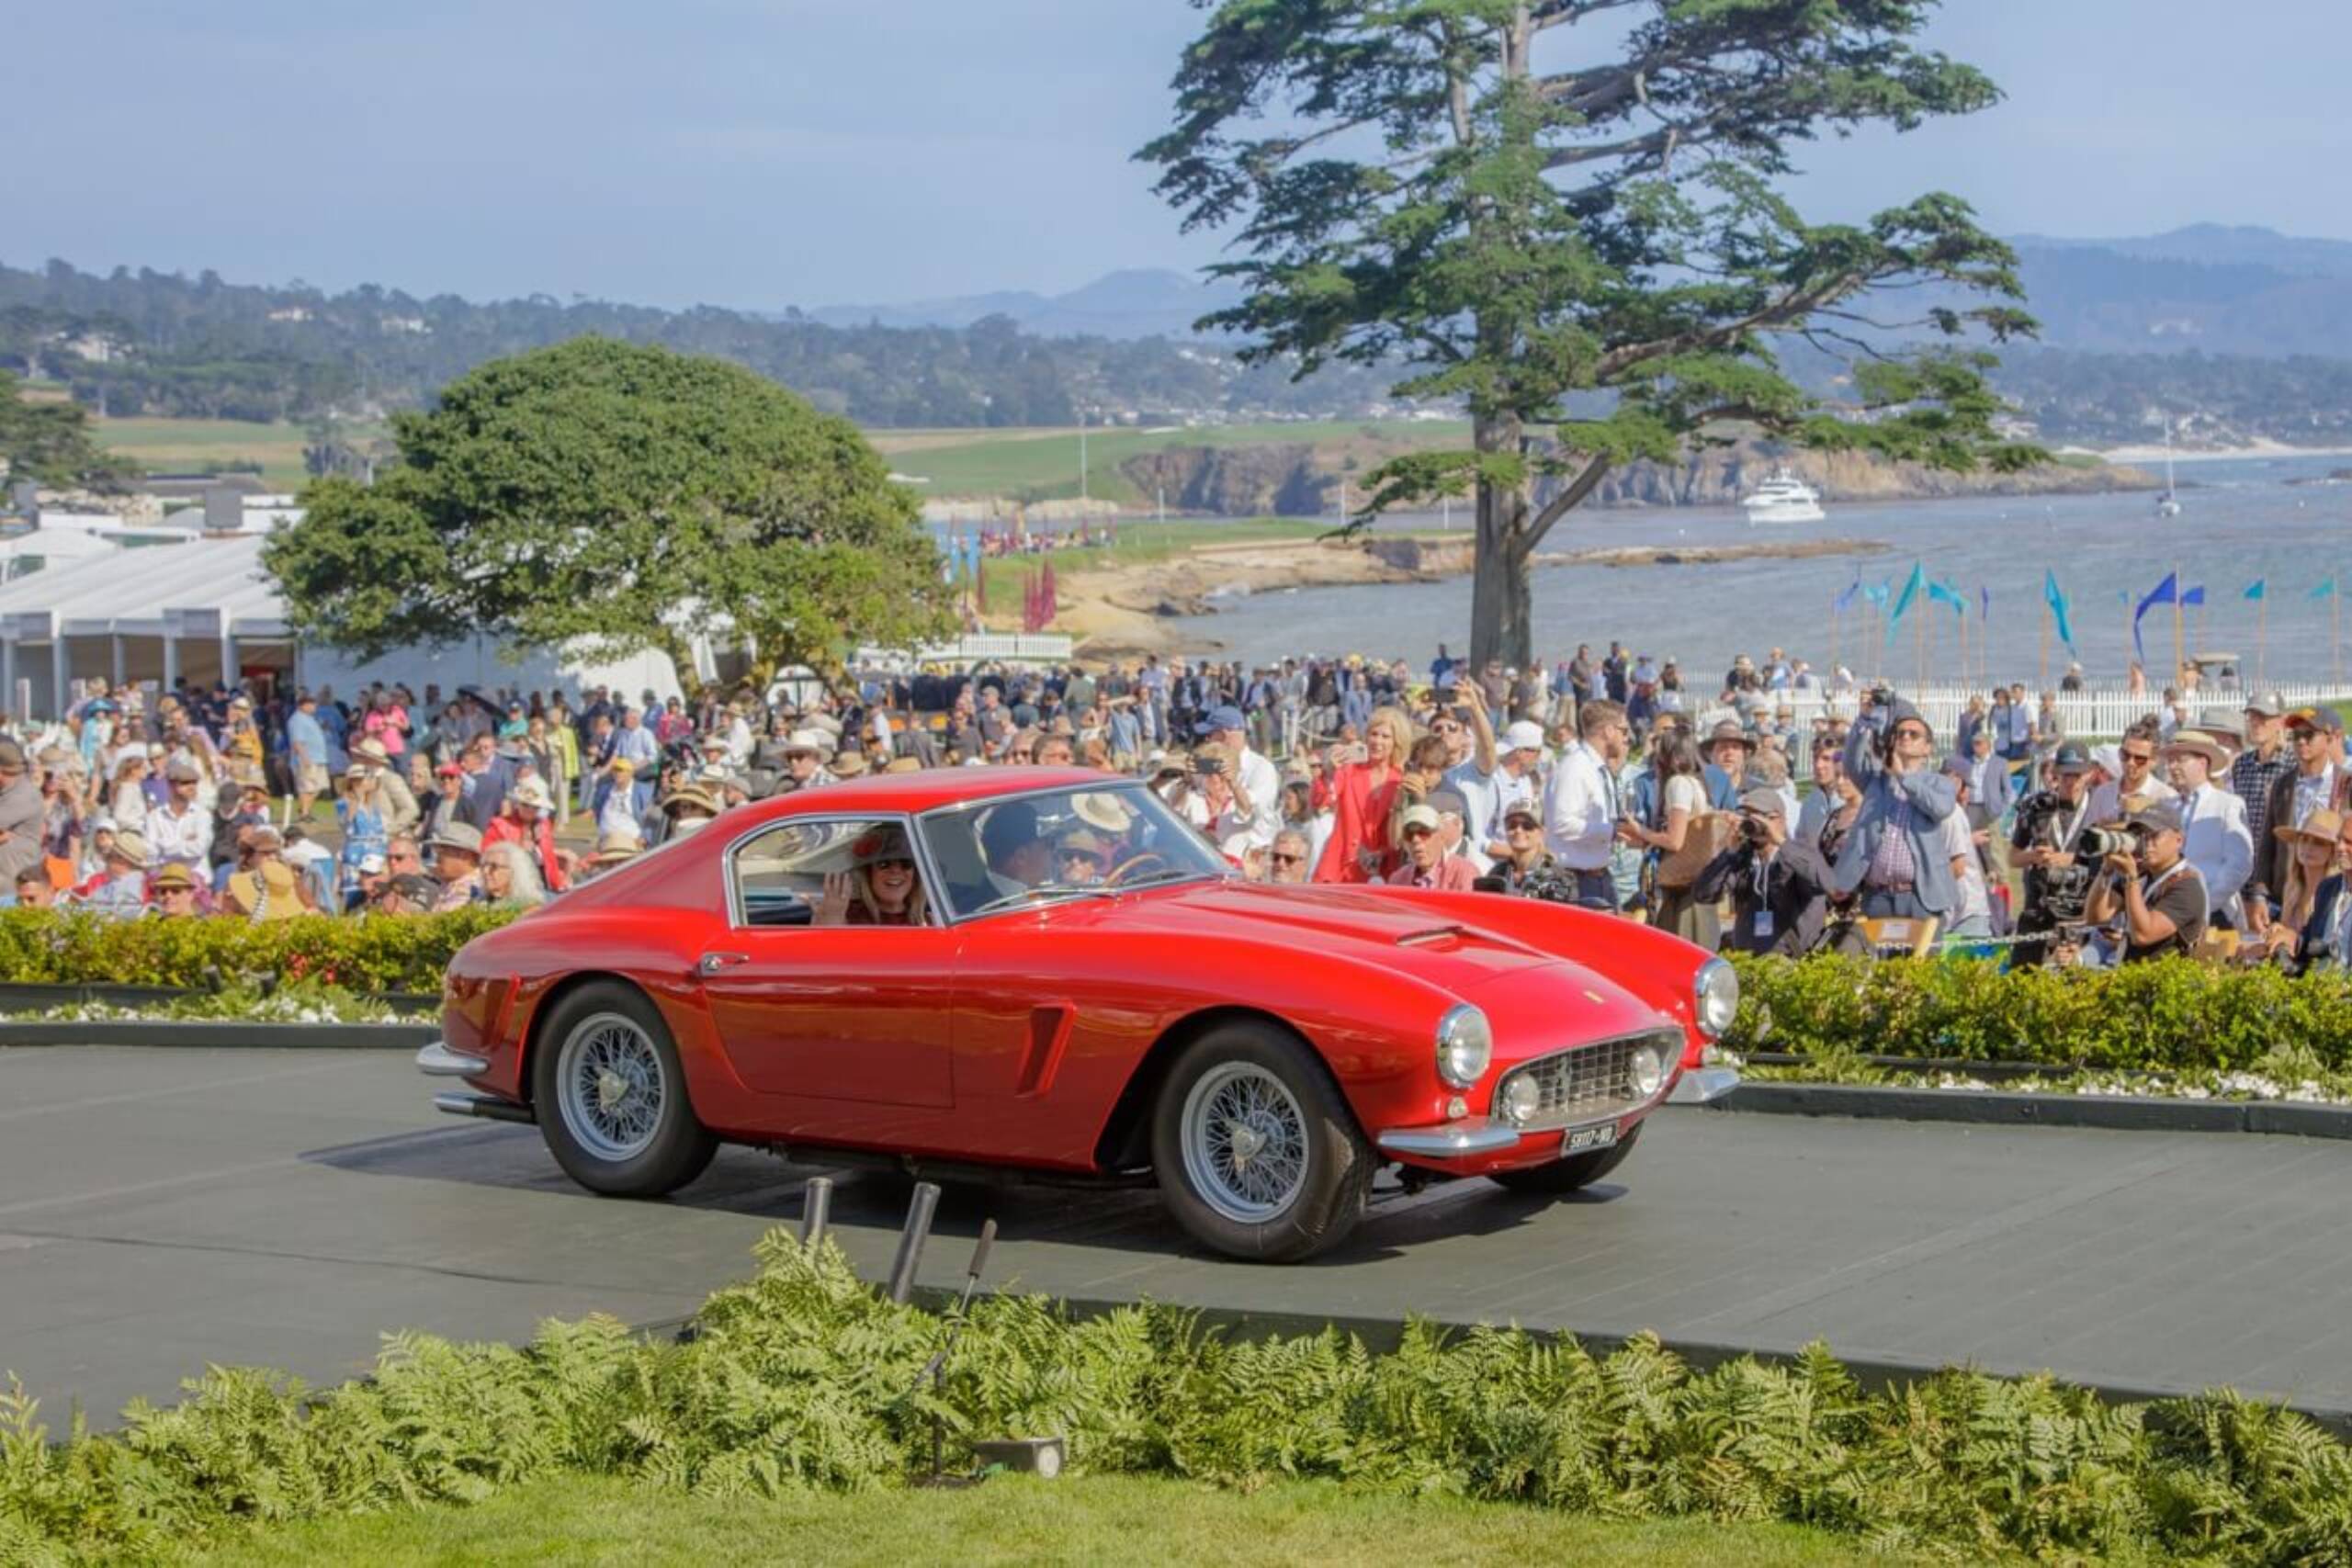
[0,644,2352,966]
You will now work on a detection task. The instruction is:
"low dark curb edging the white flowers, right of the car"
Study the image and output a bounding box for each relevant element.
[1701,1081,2352,1138]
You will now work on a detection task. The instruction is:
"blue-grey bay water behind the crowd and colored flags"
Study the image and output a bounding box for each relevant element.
[1176,456,2352,684]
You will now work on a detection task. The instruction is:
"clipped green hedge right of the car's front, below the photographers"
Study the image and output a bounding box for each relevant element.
[1724,954,2352,1072]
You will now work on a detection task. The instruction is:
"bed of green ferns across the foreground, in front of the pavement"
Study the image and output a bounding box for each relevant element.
[0,1232,2352,1563]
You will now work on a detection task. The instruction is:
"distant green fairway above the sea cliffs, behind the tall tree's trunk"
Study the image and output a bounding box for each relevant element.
[868,419,1467,505]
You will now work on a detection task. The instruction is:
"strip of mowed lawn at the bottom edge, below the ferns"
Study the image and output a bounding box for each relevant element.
[193,1476,1894,1568]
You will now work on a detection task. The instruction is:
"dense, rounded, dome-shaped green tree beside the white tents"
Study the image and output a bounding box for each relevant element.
[264,339,953,682]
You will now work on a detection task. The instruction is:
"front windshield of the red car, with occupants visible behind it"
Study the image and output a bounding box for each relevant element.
[922,781,1232,919]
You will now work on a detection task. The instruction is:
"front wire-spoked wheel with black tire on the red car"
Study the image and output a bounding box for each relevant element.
[1152,1022,1376,1262]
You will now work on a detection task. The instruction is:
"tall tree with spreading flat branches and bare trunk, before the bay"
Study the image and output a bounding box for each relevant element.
[1138,0,2040,663]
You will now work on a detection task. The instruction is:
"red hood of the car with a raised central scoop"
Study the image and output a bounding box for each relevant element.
[1077,882,1656,1018]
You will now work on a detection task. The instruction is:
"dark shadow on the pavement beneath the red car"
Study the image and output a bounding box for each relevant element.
[301,1122,1625,1269]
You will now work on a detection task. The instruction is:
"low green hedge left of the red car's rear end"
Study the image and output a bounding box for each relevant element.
[0,909,513,995]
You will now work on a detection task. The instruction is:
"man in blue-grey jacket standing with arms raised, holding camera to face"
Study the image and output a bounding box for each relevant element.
[1830,686,1959,919]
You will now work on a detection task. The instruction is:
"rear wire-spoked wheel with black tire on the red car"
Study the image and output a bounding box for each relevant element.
[532,980,719,1199]
